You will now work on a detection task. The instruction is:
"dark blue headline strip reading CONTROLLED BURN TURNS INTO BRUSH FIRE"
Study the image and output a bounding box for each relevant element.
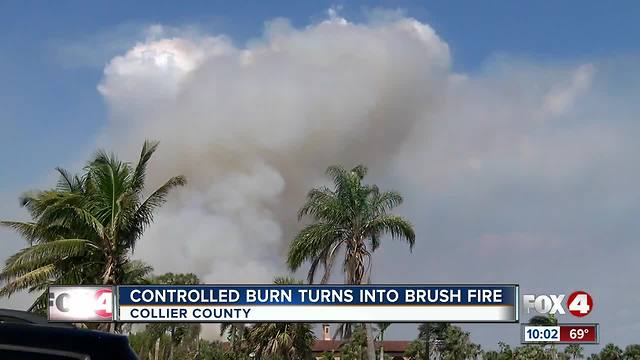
[117,284,517,306]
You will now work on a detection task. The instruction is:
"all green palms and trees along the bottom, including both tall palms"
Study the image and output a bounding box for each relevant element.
[0,141,640,360]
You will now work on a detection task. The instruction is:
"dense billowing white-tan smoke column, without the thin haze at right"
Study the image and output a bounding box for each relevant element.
[99,11,449,282]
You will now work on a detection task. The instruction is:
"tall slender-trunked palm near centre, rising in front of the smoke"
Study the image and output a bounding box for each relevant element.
[287,165,415,360]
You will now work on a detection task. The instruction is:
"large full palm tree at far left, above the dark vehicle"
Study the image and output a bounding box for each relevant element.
[0,141,186,316]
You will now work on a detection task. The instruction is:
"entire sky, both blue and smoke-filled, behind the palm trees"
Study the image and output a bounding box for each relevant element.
[0,1,640,347]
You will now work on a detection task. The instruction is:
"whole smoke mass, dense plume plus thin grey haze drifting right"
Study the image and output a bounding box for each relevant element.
[99,8,640,341]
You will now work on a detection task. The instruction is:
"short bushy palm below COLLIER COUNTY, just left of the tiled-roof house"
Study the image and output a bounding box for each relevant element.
[247,277,315,360]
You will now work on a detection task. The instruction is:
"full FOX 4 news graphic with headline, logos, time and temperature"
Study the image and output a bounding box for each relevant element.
[48,284,599,343]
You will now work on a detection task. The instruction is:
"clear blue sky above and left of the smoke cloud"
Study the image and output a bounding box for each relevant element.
[0,1,640,190]
